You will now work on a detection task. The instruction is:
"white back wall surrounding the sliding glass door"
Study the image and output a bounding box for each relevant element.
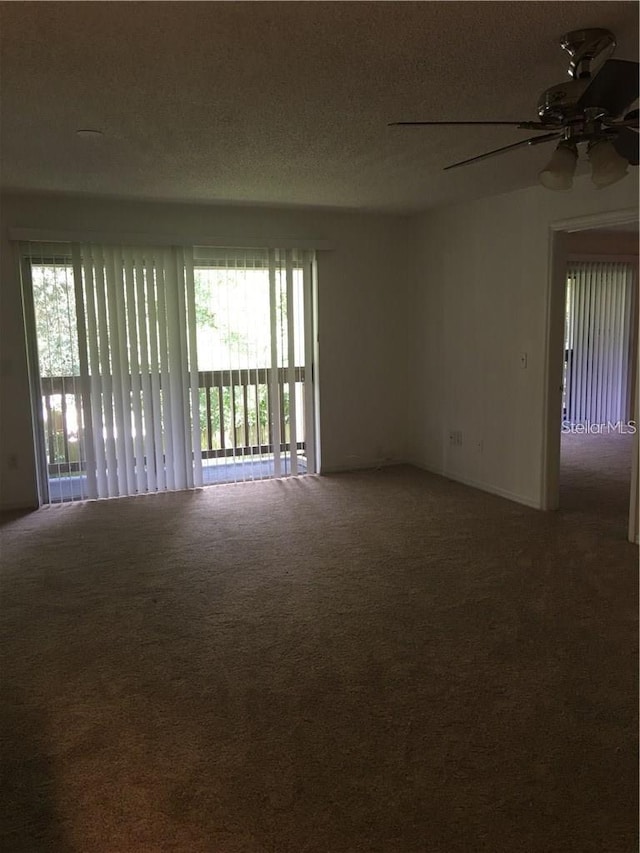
[0,194,407,509]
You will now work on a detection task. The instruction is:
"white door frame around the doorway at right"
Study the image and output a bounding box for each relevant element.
[541,208,638,540]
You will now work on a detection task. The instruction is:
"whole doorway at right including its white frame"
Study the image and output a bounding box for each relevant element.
[543,212,638,541]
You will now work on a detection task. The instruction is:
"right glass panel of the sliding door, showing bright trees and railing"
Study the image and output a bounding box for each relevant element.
[195,249,315,482]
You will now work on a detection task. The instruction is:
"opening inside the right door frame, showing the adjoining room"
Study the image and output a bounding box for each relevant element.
[560,250,637,532]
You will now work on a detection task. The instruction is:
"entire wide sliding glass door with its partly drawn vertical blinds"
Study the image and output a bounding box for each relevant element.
[23,243,315,502]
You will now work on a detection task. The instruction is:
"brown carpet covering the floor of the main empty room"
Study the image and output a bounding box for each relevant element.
[0,450,637,853]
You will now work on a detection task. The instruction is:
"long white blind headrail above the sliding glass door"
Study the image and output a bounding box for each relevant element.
[8,228,333,251]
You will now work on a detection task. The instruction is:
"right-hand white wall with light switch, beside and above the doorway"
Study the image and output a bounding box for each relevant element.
[408,176,638,506]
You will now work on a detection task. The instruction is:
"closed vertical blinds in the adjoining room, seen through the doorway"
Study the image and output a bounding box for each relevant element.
[564,261,634,424]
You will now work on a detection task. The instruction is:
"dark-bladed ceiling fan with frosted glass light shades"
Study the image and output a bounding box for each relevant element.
[389,29,640,189]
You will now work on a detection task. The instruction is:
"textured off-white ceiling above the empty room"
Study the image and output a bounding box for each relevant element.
[0,0,638,212]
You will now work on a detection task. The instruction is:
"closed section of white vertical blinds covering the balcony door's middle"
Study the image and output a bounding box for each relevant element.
[73,244,202,497]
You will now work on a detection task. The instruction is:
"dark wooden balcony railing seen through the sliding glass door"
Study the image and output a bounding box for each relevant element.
[40,367,305,477]
